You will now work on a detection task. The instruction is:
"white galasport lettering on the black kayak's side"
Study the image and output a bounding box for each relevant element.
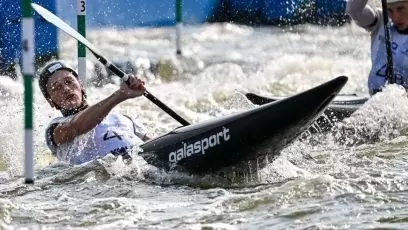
[169,127,230,163]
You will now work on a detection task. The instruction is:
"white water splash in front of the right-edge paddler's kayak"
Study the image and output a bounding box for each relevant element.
[331,85,408,145]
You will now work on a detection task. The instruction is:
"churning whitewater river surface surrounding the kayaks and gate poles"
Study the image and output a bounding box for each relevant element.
[0,17,408,229]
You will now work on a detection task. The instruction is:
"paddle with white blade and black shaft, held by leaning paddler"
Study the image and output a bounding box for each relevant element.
[31,3,190,126]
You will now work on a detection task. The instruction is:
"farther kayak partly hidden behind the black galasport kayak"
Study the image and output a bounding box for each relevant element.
[245,89,369,132]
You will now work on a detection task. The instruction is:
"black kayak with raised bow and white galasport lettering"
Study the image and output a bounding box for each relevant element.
[139,76,348,174]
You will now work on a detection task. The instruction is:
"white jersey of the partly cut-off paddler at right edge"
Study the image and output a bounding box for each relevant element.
[368,10,408,94]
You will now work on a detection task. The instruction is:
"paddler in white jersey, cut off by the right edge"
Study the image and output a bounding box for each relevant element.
[346,0,408,95]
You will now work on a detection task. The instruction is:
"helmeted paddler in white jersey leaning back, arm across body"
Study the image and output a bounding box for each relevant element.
[39,60,150,165]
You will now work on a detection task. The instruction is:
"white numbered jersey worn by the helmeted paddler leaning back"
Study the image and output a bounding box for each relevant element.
[45,112,147,165]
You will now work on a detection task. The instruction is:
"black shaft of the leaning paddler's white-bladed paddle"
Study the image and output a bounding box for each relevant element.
[91,50,190,126]
